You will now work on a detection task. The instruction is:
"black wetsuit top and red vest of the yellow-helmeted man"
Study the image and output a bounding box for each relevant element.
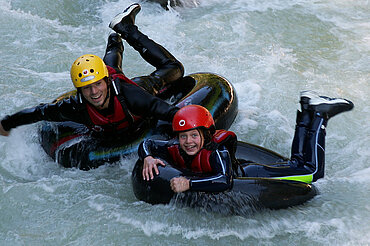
[1,67,178,134]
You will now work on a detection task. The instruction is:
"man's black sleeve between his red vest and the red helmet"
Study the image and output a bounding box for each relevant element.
[120,83,179,122]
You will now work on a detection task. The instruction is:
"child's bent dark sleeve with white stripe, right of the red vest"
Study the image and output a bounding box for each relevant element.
[190,146,232,192]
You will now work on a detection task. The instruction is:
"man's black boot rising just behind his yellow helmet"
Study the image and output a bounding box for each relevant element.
[103,33,124,72]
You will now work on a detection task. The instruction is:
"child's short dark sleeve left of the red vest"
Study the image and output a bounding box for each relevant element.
[138,139,173,160]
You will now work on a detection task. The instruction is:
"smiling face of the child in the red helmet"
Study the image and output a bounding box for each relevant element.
[179,130,203,155]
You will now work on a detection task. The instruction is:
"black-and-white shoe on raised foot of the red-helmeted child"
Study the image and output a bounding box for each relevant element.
[301,91,354,118]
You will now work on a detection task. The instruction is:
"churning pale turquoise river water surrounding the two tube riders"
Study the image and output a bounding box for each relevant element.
[0,0,370,245]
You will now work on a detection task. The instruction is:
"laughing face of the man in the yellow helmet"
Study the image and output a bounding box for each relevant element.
[81,79,109,109]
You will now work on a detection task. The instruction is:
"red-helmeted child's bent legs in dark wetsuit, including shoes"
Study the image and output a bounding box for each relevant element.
[243,92,353,183]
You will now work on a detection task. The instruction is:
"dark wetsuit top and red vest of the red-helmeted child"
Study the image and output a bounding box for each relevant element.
[138,130,237,192]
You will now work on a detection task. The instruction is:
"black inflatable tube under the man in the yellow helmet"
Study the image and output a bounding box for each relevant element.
[40,73,238,170]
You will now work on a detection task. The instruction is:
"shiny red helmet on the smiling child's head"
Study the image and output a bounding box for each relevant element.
[172,105,215,132]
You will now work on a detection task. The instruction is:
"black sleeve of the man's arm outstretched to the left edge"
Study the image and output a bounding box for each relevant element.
[1,97,83,131]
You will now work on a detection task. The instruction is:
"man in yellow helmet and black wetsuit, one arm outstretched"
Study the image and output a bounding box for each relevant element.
[0,4,184,163]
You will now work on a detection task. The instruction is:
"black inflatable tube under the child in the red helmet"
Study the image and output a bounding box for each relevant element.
[132,142,317,211]
